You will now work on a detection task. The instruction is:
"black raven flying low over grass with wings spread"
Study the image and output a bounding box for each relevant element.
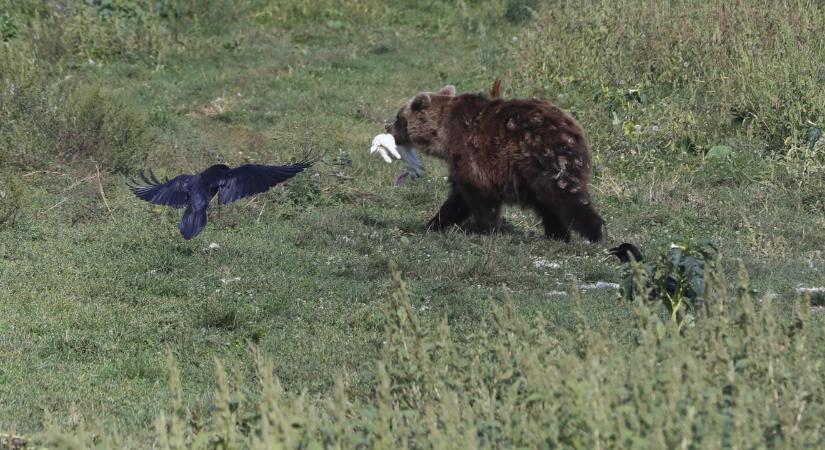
[129,161,312,240]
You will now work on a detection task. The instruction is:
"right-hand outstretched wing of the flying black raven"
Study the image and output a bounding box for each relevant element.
[219,161,312,205]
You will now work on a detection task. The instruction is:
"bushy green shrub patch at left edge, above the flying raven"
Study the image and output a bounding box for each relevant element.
[0,73,154,171]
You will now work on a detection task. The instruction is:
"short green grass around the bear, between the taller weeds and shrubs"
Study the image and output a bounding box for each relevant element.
[0,2,825,442]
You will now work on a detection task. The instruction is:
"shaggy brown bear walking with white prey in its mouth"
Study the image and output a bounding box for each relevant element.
[386,82,604,242]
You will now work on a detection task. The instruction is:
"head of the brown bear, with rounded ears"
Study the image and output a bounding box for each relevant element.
[386,85,455,159]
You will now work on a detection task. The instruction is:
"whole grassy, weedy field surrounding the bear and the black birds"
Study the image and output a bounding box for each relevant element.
[0,0,825,448]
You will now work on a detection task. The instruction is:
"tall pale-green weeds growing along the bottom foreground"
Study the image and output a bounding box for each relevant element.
[41,266,825,449]
